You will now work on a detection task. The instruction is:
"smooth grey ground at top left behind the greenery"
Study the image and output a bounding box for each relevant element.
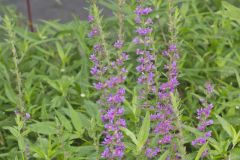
[0,0,110,21]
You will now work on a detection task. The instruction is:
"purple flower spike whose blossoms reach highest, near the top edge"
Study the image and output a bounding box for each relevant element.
[133,1,156,100]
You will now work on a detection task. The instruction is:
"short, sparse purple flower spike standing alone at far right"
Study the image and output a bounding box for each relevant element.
[192,83,213,157]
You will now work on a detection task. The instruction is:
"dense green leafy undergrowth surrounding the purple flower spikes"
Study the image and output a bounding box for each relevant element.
[0,0,240,160]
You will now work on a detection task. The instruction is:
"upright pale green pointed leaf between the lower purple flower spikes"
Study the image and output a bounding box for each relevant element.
[137,112,150,151]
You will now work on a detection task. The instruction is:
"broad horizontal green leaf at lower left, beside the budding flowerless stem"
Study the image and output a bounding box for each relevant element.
[28,121,57,135]
